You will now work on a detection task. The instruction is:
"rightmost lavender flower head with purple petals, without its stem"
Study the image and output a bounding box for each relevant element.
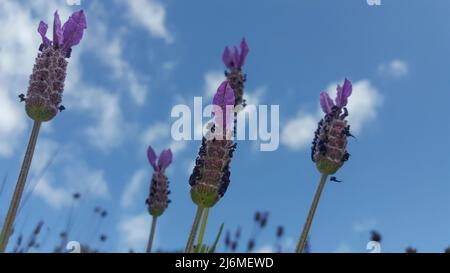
[311,79,352,175]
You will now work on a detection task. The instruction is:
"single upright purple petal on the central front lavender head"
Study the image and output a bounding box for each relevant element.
[213,81,235,129]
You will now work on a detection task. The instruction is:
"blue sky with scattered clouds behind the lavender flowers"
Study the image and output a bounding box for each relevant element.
[0,0,450,252]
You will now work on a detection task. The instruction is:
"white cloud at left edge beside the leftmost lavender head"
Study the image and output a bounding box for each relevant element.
[0,1,47,156]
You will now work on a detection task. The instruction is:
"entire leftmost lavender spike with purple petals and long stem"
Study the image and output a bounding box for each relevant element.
[0,10,87,252]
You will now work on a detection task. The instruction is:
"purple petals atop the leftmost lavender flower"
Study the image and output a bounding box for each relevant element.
[38,10,87,56]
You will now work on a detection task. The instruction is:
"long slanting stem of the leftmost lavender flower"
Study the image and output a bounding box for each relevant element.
[0,121,41,253]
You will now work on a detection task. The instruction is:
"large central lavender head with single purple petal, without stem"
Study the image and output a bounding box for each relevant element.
[189,81,236,208]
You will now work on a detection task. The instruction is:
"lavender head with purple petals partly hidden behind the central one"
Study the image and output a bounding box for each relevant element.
[222,38,249,108]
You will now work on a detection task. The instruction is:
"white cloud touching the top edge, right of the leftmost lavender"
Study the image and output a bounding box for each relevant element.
[126,0,174,43]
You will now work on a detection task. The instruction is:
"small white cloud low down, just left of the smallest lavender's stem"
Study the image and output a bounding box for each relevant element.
[118,213,151,252]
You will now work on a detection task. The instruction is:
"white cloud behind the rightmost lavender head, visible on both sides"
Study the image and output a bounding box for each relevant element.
[281,80,383,149]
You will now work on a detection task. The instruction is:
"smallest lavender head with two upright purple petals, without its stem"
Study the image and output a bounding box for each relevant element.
[145,146,172,217]
